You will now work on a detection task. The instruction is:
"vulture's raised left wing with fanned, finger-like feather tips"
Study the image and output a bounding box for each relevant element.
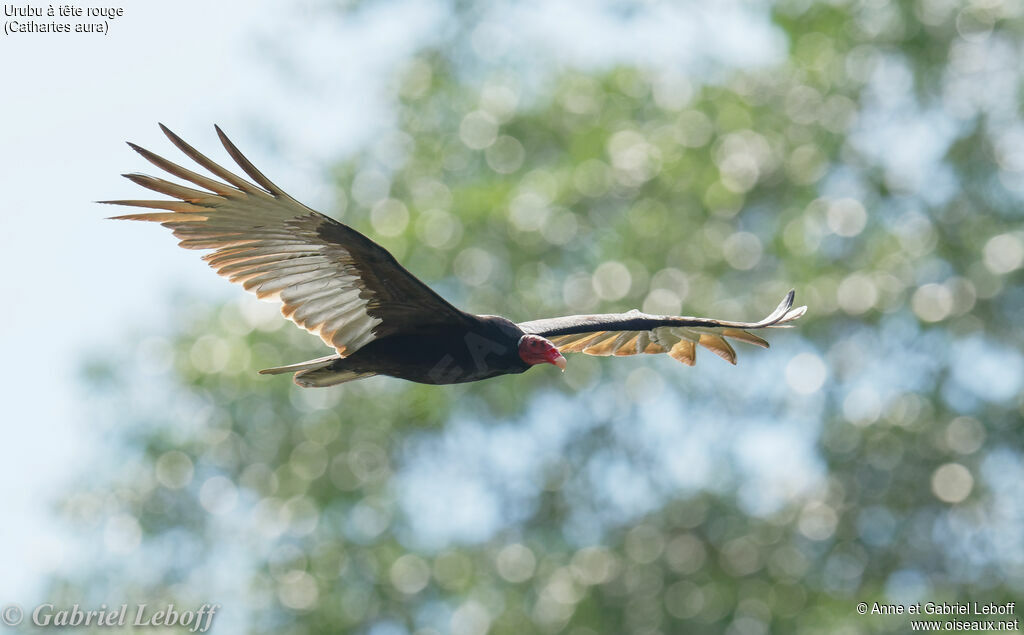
[102,124,468,355]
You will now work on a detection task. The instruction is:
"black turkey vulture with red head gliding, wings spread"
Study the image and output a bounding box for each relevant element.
[102,124,806,387]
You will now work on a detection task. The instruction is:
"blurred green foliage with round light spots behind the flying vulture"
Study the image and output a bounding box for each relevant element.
[53,0,1024,635]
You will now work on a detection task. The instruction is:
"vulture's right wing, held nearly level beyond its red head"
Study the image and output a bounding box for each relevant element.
[519,291,807,366]
